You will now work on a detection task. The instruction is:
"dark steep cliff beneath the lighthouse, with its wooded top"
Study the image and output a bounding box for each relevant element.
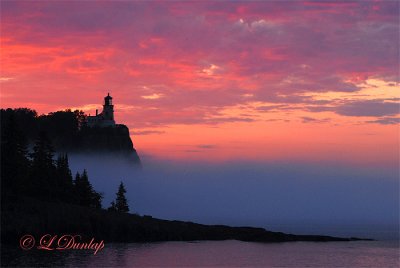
[1,108,140,165]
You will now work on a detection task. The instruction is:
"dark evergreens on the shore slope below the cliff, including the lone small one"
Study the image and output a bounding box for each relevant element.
[1,112,129,212]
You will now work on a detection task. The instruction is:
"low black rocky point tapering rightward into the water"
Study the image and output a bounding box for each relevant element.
[1,198,372,244]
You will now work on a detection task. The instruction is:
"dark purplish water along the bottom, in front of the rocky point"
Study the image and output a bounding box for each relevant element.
[2,240,400,267]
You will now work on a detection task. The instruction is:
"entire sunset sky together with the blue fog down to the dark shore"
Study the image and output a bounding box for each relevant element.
[0,1,400,239]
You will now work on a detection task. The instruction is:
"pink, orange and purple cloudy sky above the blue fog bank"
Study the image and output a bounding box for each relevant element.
[0,1,400,167]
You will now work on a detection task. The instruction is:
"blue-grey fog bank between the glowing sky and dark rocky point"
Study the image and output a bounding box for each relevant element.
[70,155,399,239]
